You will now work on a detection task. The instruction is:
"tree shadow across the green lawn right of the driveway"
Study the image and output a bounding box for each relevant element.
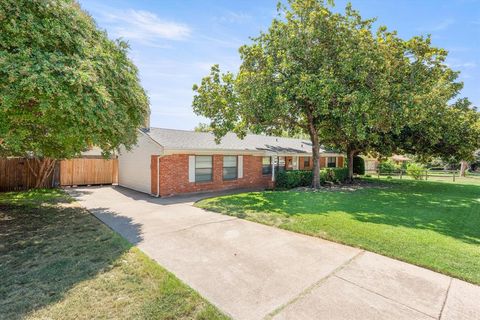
[209,182,480,244]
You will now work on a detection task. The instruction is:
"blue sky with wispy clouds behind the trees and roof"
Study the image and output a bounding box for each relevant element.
[80,0,480,129]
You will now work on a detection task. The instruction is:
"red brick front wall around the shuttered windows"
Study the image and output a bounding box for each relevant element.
[151,154,273,196]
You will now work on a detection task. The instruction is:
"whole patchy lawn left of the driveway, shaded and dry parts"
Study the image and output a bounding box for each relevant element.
[0,190,227,320]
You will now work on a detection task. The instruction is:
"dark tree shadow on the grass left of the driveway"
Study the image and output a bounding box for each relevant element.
[0,203,141,319]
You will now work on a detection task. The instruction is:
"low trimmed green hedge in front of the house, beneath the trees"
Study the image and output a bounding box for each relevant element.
[275,168,348,189]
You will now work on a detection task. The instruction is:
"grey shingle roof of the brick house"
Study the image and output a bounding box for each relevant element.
[145,128,333,153]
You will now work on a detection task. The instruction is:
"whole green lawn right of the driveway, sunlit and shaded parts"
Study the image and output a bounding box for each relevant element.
[196,179,480,284]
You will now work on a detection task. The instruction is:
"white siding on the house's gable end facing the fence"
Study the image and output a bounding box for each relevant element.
[118,134,162,193]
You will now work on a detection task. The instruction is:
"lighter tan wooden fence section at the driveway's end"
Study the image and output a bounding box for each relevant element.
[60,158,118,186]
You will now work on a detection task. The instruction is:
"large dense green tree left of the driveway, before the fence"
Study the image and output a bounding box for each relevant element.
[0,0,149,185]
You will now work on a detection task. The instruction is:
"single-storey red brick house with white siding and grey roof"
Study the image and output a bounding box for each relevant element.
[118,128,344,197]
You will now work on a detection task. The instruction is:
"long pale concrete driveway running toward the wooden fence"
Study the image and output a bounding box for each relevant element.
[67,187,480,320]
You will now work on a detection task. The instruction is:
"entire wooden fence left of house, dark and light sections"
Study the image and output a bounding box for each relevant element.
[0,158,118,192]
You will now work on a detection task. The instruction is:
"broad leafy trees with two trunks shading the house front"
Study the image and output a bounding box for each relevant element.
[193,0,480,187]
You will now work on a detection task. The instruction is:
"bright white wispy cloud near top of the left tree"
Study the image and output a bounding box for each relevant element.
[98,8,191,46]
